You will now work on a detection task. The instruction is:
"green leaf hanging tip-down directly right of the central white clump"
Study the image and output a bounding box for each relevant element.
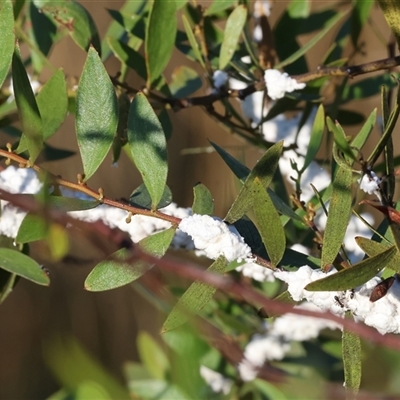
[252,178,286,266]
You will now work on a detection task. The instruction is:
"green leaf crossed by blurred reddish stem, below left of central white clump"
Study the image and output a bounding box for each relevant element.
[85,227,176,292]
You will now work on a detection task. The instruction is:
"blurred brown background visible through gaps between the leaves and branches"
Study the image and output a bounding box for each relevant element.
[0,0,396,399]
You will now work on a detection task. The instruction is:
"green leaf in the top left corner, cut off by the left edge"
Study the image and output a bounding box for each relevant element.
[0,0,15,87]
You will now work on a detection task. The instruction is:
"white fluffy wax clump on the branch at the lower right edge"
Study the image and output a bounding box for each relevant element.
[275,265,400,334]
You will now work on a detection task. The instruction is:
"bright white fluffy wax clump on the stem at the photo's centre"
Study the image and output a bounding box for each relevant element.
[179,214,251,262]
